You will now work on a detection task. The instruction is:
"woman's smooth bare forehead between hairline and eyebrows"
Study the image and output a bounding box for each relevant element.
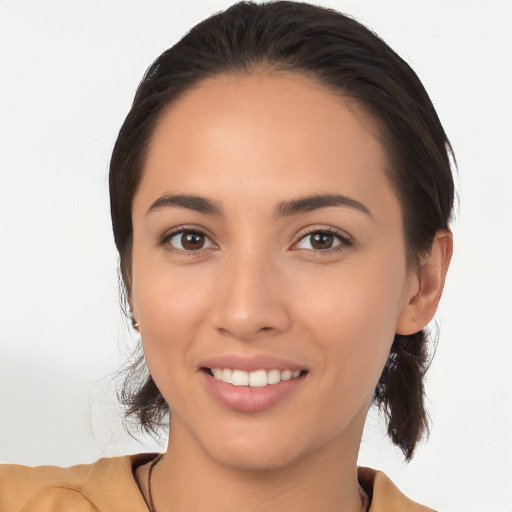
[136,72,400,218]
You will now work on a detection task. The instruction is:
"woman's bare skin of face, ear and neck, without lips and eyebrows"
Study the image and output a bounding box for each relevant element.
[130,71,451,512]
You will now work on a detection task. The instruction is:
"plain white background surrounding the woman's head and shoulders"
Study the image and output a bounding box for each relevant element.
[0,0,512,512]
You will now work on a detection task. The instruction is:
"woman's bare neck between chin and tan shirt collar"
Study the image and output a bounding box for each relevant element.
[146,414,363,512]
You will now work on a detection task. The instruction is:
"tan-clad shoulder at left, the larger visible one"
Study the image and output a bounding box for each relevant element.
[0,454,153,512]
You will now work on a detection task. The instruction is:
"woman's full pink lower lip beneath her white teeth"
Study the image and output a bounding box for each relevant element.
[202,372,305,412]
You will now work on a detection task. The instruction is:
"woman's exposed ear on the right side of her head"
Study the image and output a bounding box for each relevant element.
[396,229,453,335]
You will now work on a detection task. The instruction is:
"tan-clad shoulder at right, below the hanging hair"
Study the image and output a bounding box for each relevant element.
[358,467,434,512]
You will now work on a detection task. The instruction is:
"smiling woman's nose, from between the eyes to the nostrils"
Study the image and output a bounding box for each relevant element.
[212,254,291,341]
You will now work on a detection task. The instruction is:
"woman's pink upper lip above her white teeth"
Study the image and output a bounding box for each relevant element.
[199,354,306,372]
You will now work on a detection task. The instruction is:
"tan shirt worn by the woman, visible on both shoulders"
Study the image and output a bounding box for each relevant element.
[0,454,432,512]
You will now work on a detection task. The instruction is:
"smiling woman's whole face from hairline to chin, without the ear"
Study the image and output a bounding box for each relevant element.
[130,73,417,468]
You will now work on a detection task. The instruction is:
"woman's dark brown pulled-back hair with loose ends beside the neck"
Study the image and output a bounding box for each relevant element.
[110,1,454,459]
